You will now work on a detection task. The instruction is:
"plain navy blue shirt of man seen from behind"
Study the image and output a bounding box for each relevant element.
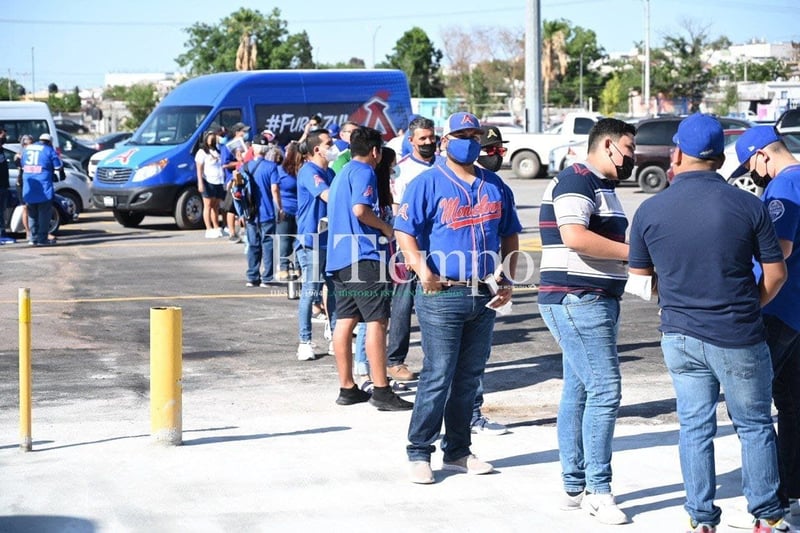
[630,171,783,348]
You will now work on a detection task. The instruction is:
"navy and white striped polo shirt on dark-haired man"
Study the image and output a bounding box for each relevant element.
[539,163,628,304]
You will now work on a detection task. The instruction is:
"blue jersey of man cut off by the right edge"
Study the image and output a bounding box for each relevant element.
[758,165,800,331]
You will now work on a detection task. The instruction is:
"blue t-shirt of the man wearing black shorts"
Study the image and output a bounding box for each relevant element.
[326,159,386,272]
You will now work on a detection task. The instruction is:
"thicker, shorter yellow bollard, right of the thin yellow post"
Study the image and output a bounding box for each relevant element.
[150,307,183,445]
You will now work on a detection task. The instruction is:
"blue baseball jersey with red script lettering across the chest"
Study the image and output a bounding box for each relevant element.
[394,159,522,281]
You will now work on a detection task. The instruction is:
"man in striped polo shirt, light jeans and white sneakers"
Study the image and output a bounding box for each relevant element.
[539,119,636,524]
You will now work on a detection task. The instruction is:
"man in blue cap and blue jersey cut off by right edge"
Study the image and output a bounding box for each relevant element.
[733,126,800,514]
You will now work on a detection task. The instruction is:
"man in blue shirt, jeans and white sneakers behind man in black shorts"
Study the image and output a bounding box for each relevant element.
[295,129,338,361]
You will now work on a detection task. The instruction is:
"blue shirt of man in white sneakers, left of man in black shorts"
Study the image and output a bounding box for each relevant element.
[297,161,334,249]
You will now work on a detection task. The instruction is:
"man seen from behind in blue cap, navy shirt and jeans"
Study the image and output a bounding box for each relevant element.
[630,113,790,533]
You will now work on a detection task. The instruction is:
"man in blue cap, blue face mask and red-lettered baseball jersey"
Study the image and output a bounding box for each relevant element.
[395,112,522,484]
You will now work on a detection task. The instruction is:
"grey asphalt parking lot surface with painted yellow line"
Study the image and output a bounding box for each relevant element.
[0,171,675,426]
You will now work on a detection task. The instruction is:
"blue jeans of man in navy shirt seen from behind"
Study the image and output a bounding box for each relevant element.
[661,333,783,525]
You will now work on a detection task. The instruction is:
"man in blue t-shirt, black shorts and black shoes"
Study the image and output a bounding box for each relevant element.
[327,127,414,411]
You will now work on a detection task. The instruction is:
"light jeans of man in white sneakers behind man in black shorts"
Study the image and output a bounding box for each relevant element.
[295,246,336,342]
